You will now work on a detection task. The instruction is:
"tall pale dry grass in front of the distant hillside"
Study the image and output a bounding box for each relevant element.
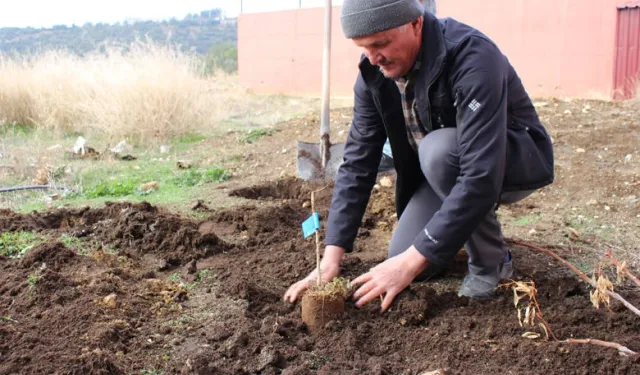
[0,43,336,143]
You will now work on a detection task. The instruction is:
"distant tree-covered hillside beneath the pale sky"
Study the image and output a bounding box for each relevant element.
[0,9,237,55]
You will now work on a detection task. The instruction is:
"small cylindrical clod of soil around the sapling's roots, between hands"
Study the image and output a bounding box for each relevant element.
[301,291,344,332]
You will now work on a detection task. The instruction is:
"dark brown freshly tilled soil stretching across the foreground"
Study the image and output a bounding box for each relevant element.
[0,179,640,375]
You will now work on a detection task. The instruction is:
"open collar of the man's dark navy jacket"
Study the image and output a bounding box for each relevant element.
[359,11,447,90]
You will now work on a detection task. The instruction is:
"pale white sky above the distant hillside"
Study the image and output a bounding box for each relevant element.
[0,0,342,28]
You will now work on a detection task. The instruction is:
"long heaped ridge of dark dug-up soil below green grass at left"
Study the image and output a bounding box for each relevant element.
[0,202,231,268]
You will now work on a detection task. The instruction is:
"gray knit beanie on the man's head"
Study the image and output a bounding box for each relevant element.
[340,0,424,39]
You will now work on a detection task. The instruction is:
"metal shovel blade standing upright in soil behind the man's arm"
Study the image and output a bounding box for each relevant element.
[297,142,344,182]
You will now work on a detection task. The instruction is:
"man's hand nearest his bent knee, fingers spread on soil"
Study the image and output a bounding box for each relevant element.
[353,246,429,312]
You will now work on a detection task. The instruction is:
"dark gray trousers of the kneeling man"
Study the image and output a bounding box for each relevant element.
[389,128,533,272]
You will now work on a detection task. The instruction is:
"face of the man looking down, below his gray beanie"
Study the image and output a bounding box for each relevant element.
[353,17,423,79]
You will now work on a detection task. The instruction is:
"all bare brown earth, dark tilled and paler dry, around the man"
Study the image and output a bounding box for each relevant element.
[0,100,640,375]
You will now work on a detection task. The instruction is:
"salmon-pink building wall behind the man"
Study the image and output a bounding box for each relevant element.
[238,0,620,98]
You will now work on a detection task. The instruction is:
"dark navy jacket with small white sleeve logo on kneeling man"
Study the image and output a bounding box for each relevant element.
[325,12,553,265]
